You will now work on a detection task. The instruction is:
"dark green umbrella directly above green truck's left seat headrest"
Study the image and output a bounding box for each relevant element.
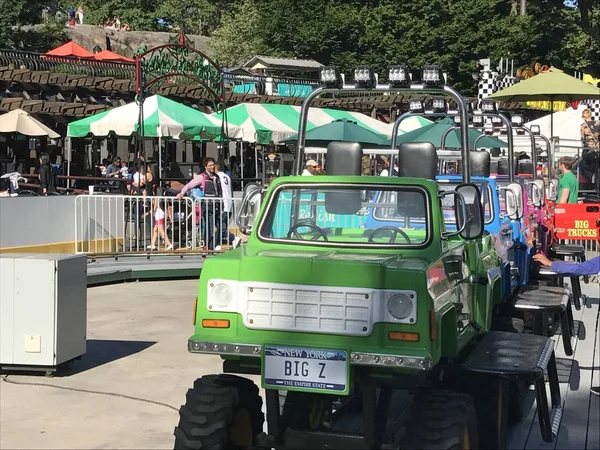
[283,119,387,147]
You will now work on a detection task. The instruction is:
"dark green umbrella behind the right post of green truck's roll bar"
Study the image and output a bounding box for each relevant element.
[387,118,506,149]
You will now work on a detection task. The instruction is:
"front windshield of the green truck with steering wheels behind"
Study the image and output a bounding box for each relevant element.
[259,184,431,247]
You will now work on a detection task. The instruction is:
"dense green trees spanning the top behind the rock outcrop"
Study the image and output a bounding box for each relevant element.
[0,0,600,89]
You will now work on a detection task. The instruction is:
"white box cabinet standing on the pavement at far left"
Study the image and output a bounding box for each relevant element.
[0,253,87,371]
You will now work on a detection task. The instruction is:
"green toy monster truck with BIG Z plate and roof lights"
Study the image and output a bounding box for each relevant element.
[174,66,560,449]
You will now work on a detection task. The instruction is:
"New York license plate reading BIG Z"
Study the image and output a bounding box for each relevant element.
[263,345,349,395]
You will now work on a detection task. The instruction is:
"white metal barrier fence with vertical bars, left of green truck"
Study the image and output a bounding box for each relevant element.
[75,195,241,254]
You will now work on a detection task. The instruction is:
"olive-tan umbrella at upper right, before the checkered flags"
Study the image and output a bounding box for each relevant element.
[487,67,600,137]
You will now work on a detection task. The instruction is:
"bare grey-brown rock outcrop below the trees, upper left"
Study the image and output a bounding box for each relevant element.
[65,25,214,57]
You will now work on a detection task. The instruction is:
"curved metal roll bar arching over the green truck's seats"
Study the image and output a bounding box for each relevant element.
[293,84,471,183]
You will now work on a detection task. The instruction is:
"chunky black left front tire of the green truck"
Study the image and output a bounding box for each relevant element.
[173,374,264,450]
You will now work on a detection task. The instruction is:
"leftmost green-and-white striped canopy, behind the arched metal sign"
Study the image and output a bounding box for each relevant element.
[67,95,225,139]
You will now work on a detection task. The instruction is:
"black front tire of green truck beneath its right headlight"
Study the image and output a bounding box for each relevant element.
[400,391,479,450]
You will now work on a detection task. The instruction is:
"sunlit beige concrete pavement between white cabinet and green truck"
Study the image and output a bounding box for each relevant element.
[0,280,259,449]
